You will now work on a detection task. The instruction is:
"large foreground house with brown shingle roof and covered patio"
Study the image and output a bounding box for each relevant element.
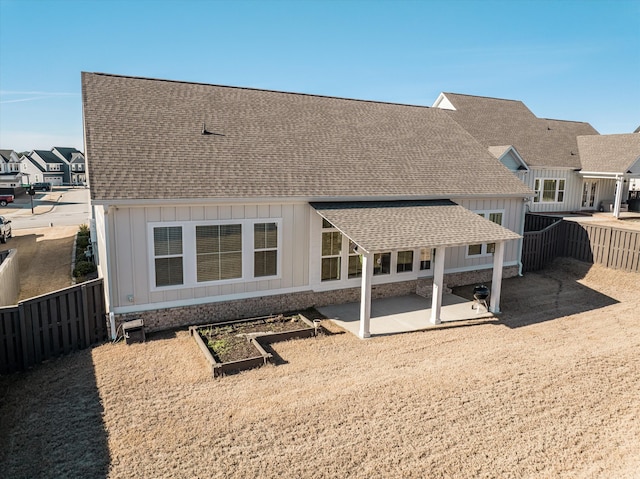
[82,73,534,337]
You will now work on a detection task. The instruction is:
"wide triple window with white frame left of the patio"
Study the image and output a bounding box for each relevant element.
[147,218,282,290]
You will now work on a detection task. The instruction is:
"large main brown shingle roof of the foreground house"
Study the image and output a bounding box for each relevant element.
[82,73,532,202]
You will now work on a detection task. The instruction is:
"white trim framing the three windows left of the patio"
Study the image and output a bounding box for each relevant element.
[147,218,282,292]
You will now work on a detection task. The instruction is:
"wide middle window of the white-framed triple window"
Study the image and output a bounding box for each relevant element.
[196,224,242,283]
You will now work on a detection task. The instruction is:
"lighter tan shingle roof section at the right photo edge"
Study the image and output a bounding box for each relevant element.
[578,133,640,173]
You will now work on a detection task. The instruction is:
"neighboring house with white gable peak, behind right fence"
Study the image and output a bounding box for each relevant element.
[433,93,640,217]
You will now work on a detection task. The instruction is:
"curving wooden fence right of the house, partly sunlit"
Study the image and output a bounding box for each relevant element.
[522,215,640,273]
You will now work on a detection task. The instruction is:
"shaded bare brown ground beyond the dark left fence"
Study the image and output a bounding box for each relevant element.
[5,226,78,301]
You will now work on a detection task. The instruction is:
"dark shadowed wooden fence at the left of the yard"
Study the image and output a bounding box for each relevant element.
[0,278,107,374]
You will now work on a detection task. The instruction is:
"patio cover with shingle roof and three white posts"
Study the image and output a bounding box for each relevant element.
[310,200,520,339]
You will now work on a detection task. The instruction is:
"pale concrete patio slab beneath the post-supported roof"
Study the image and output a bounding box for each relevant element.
[317,294,495,337]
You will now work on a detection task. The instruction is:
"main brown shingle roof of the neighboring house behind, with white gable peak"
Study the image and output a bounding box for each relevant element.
[444,93,598,168]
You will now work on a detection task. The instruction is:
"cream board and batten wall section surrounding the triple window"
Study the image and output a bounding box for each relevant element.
[109,203,309,308]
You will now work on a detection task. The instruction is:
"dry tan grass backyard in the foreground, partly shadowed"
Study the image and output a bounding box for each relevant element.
[0,260,640,478]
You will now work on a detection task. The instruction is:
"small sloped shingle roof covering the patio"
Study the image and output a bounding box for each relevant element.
[311,201,520,253]
